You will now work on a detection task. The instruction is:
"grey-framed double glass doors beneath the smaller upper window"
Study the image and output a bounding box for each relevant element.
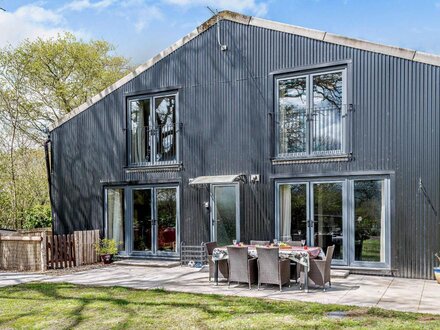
[128,187,178,255]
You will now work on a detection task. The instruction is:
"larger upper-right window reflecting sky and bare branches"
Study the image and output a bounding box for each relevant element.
[276,69,346,157]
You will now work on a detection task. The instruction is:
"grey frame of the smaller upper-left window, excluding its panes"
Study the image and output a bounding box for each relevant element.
[125,90,181,168]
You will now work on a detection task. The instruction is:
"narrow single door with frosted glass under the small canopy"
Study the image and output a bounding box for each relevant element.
[211,184,240,246]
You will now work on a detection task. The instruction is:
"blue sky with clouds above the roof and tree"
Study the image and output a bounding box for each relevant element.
[0,0,440,65]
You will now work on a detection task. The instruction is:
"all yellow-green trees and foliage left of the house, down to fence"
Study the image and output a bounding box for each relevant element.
[0,33,130,228]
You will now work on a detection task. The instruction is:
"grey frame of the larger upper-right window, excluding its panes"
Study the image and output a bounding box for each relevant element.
[274,64,349,160]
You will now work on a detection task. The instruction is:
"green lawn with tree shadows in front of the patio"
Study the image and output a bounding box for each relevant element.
[0,283,440,330]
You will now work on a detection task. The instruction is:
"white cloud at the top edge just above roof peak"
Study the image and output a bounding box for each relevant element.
[164,0,267,16]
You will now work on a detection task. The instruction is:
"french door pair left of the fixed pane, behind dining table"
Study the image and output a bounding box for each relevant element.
[276,181,347,263]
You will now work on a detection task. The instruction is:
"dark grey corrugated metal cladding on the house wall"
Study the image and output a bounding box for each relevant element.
[52,21,440,278]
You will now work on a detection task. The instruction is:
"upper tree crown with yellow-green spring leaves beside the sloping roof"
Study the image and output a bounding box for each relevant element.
[0,33,130,142]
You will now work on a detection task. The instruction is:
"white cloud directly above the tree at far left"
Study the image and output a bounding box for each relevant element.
[0,5,83,47]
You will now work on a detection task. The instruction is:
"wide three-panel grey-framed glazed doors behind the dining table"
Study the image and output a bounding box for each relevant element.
[276,178,389,267]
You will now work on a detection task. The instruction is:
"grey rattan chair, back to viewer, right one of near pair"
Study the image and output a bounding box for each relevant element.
[257,247,290,291]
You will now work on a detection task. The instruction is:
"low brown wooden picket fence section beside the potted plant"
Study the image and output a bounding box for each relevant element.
[46,230,99,269]
